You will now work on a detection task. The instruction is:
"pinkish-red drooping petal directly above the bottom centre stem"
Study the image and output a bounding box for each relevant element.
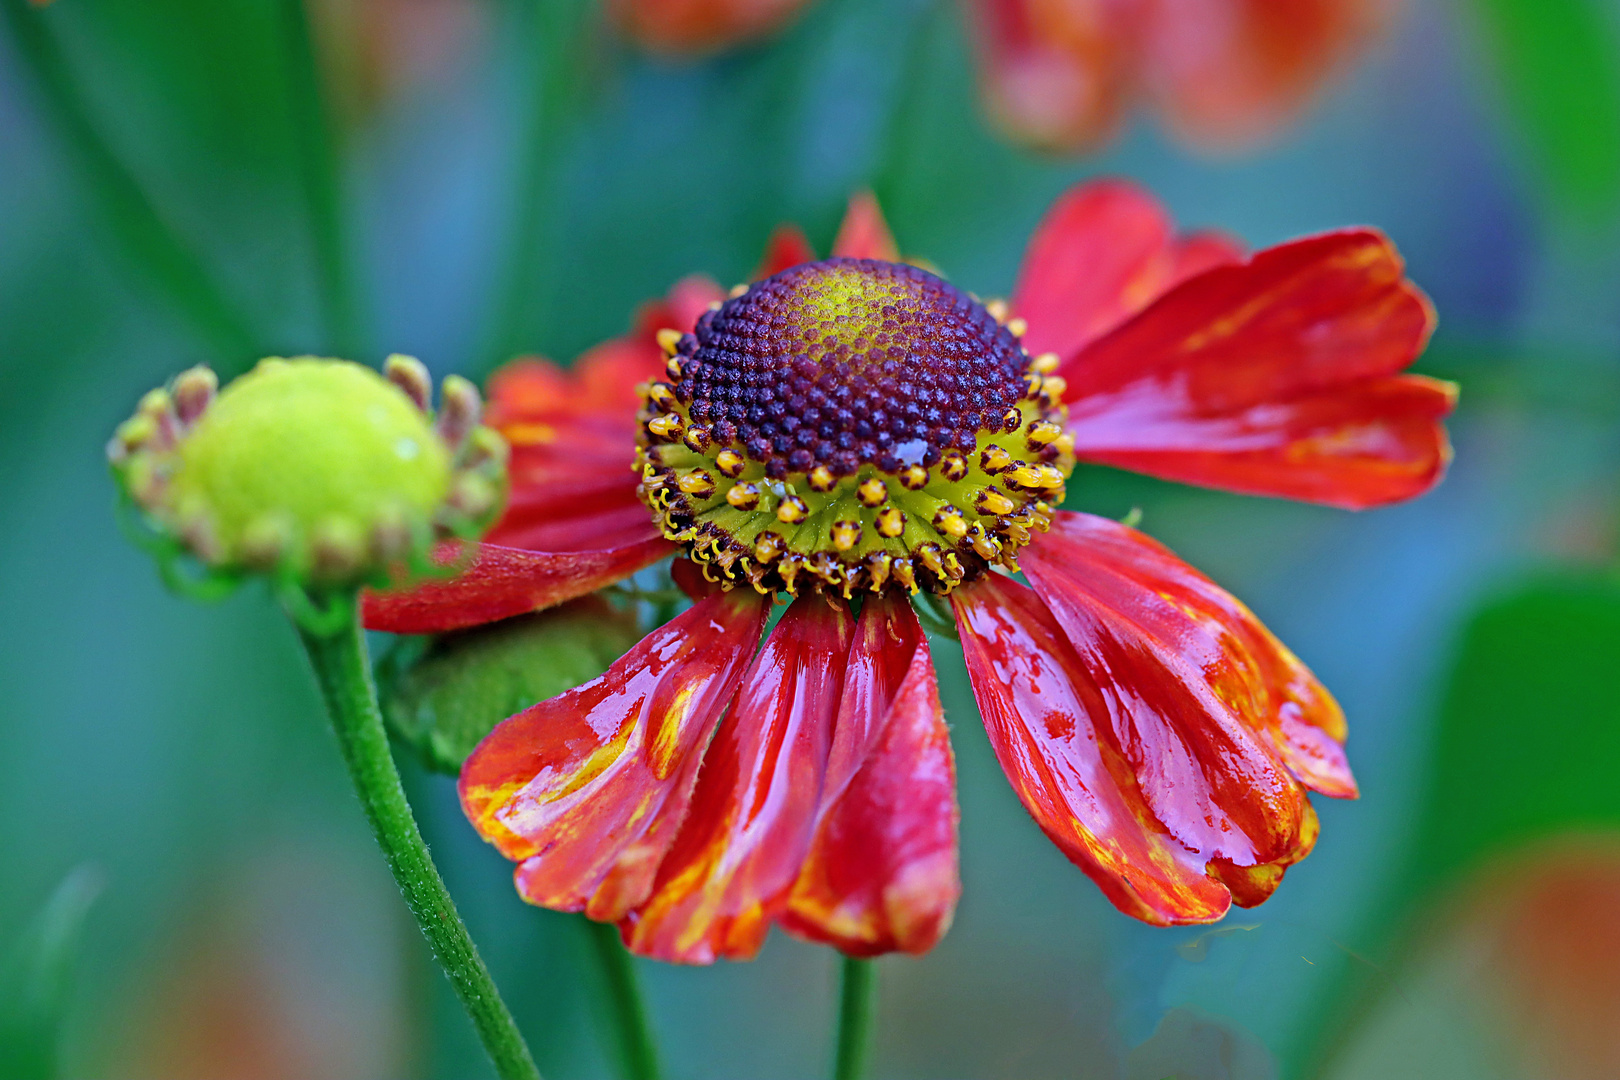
[779,594,962,957]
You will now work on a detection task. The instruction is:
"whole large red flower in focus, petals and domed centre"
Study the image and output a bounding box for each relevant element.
[368,181,1455,963]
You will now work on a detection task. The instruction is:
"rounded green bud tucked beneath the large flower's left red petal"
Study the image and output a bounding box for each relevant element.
[377,596,642,776]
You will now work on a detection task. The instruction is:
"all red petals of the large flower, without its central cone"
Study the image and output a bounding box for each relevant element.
[366,181,1455,963]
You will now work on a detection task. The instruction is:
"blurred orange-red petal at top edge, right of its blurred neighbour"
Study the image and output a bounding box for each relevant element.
[1142,0,1392,147]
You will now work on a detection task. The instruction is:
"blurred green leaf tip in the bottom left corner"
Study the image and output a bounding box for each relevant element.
[0,866,102,1080]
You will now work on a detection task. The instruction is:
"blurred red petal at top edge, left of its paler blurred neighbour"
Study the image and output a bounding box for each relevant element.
[969,0,1142,151]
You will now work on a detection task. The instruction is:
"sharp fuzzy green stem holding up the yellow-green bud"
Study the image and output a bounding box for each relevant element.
[298,597,539,1080]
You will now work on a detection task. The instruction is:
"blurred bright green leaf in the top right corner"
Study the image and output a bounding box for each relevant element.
[1474,0,1620,212]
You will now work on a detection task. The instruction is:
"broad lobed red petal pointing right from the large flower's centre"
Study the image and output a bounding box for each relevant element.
[1061,228,1455,508]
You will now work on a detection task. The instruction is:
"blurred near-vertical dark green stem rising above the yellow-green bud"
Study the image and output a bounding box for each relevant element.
[277,0,360,356]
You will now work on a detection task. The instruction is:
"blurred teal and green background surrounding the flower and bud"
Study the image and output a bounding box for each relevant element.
[0,0,1620,1080]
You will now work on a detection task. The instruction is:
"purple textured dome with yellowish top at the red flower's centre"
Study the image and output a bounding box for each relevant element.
[674,259,1029,478]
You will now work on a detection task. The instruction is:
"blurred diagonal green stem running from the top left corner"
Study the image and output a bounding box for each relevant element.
[0,0,259,374]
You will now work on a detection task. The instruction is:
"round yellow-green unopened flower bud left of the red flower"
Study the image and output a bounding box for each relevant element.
[109,356,505,589]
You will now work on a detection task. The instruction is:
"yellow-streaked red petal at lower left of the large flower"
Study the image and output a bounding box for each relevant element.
[460,591,770,920]
